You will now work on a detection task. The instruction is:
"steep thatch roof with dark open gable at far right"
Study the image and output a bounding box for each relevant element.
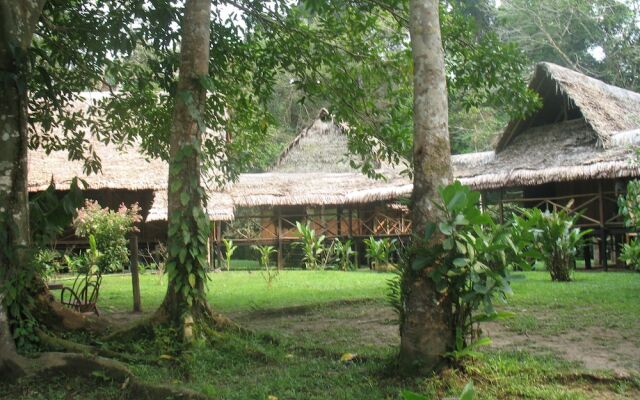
[452,63,640,189]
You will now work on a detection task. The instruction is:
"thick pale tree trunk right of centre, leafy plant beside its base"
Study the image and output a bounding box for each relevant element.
[400,0,454,373]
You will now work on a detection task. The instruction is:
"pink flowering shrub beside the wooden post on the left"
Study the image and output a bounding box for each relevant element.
[73,200,142,272]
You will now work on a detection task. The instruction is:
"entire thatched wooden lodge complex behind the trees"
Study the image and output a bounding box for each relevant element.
[29,63,640,266]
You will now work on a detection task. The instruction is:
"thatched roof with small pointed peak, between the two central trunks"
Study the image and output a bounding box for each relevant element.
[229,110,413,207]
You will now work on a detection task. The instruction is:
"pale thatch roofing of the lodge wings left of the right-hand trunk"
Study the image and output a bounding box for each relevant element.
[28,98,412,222]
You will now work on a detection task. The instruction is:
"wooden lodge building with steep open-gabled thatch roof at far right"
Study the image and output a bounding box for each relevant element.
[453,63,640,267]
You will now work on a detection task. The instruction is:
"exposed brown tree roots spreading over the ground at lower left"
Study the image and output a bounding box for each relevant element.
[0,293,255,400]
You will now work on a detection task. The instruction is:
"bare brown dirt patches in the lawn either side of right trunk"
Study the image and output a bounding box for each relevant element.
[233,301,640,375]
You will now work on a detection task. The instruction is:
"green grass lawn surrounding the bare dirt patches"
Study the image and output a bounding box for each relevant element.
[5,271,640,399]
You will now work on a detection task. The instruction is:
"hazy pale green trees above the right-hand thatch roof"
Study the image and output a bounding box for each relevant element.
[497,0,640,91]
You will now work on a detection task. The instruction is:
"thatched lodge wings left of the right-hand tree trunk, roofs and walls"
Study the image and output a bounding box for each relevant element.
[29,99,412,265]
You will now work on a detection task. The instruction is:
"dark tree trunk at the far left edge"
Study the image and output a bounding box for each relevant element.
[0,0,44,376]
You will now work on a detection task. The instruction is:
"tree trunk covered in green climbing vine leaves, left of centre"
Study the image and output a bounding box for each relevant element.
[159,0,211,339]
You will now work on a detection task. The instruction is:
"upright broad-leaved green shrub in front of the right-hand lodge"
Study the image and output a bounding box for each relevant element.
[513,204,591,282]
